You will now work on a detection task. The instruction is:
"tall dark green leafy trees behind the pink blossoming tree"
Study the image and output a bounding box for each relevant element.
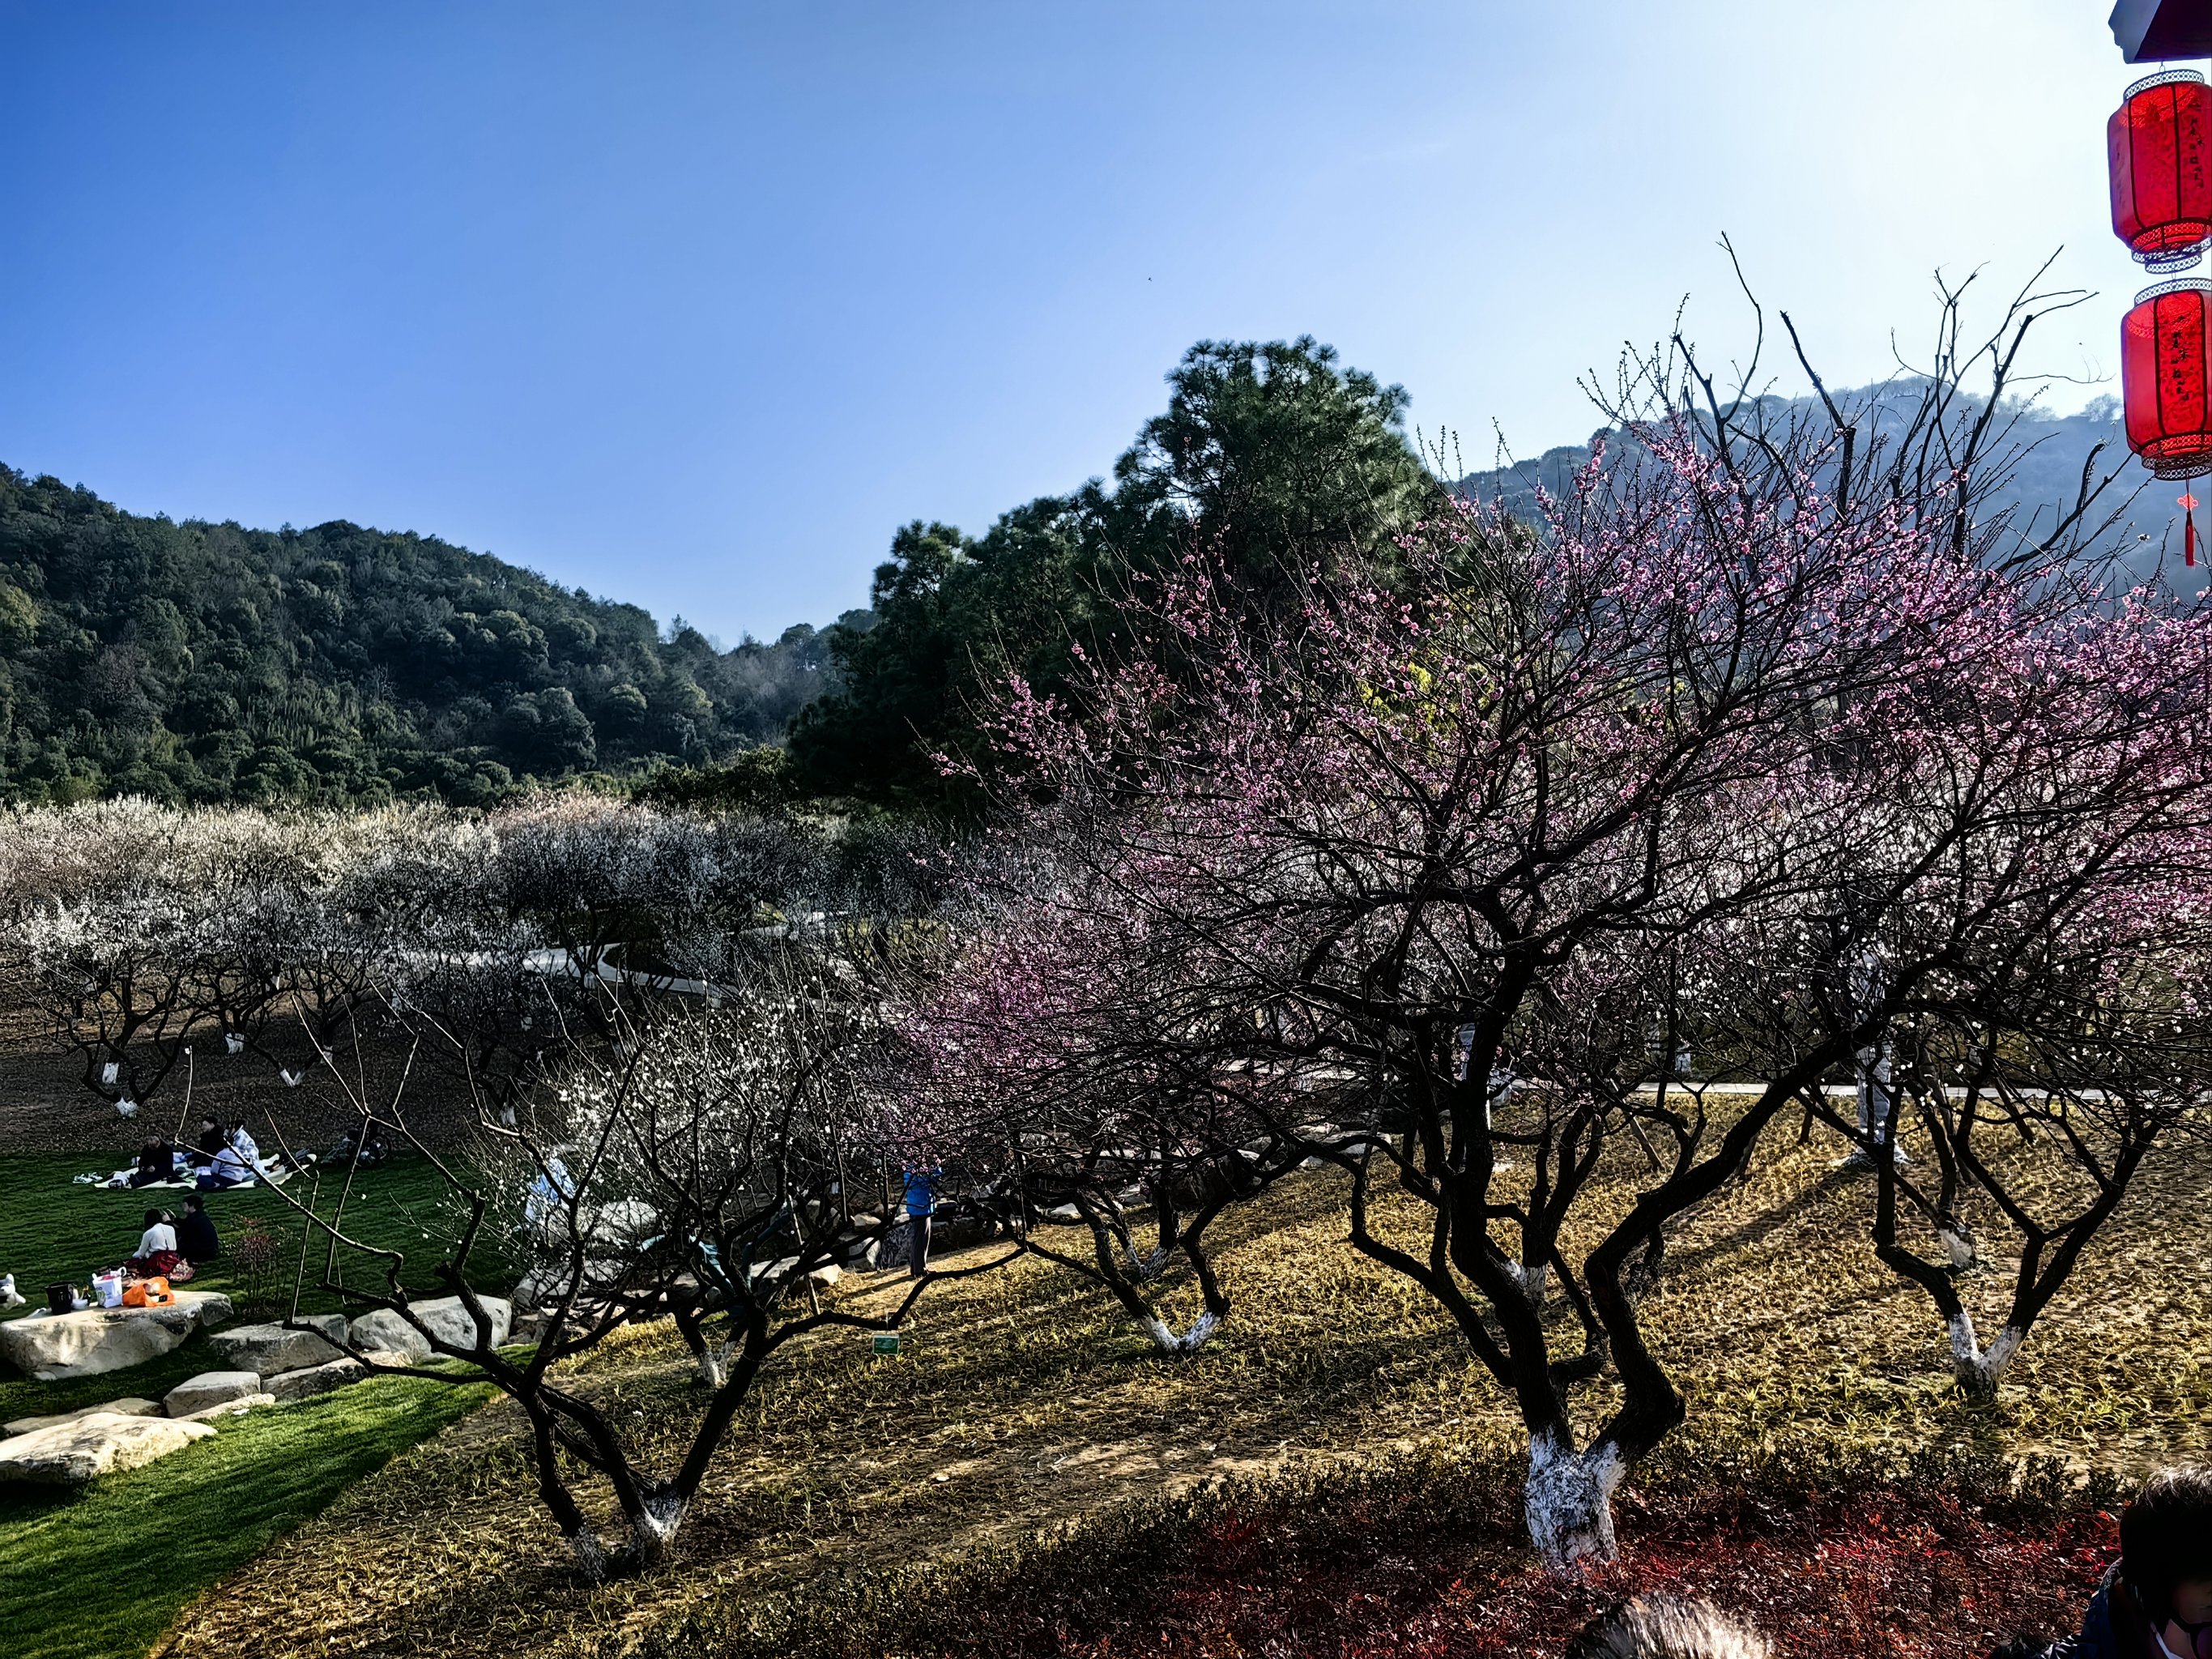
[792,339,1443,808]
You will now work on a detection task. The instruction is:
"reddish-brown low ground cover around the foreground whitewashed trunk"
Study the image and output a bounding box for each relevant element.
[663,1458,2119,1659]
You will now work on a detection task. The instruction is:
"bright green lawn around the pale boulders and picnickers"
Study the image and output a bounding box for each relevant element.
[0,1153,509,1659]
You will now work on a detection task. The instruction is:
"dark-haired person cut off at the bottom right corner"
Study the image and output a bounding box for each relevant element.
[1993,1469,2212,1659]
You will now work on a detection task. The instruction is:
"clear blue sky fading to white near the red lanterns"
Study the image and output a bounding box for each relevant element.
[0,0,2139,642]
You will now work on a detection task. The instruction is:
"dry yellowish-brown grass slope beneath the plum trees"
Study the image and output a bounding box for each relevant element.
[170,1124,2212,1659]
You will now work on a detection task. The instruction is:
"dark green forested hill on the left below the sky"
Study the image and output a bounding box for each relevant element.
[0,467,867,803]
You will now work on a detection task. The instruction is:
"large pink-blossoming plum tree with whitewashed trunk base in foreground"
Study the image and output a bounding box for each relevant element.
[964,292,2206,1566]
